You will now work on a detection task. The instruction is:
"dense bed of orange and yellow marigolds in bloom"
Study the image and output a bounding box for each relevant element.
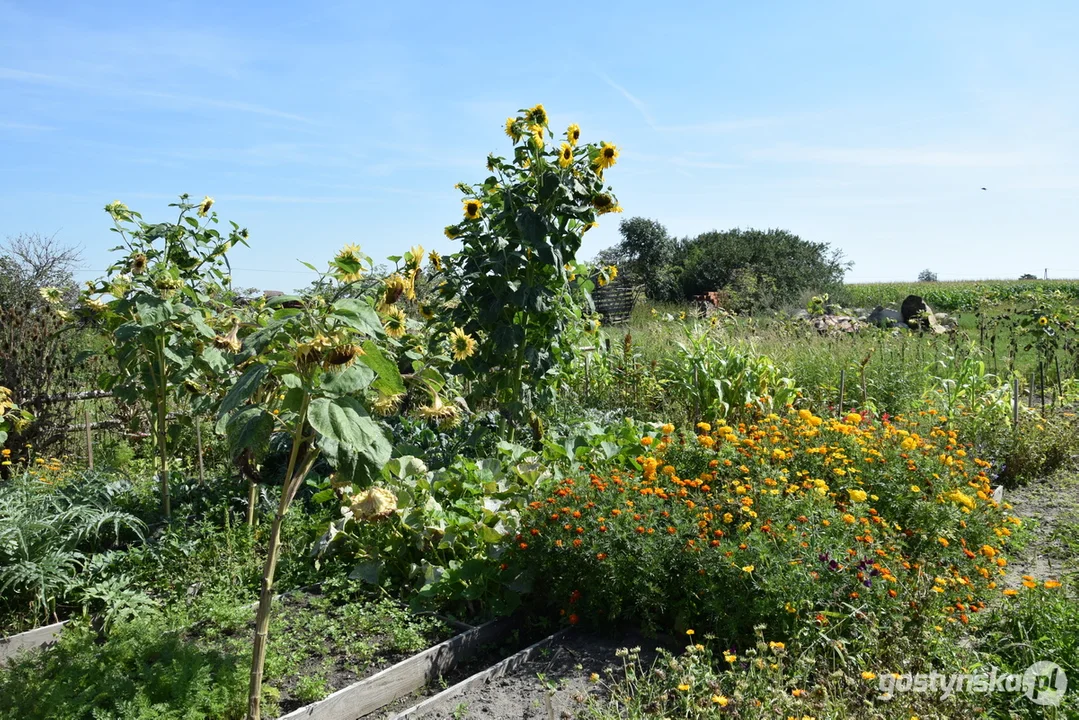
[514,409,1035,641]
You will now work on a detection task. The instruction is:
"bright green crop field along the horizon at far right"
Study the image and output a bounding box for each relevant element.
[836,280,1079,312]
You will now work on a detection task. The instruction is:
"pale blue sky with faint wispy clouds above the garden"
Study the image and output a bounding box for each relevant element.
[0,0,1079,289]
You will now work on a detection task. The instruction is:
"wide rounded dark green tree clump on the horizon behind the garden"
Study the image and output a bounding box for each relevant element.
[680,229,850,310]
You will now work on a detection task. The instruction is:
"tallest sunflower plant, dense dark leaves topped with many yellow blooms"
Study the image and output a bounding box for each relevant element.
[434,106,622,427]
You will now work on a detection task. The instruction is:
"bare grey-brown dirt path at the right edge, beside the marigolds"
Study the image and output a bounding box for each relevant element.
[1003,471,1079,587]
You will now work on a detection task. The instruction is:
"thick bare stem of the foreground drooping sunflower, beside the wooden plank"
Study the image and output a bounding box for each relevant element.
[247,396,318,720]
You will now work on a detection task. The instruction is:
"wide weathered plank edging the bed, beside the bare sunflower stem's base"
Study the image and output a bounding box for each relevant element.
[278,617,517,720]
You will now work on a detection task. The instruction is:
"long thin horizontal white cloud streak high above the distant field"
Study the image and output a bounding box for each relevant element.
[748,145,1044,167]
